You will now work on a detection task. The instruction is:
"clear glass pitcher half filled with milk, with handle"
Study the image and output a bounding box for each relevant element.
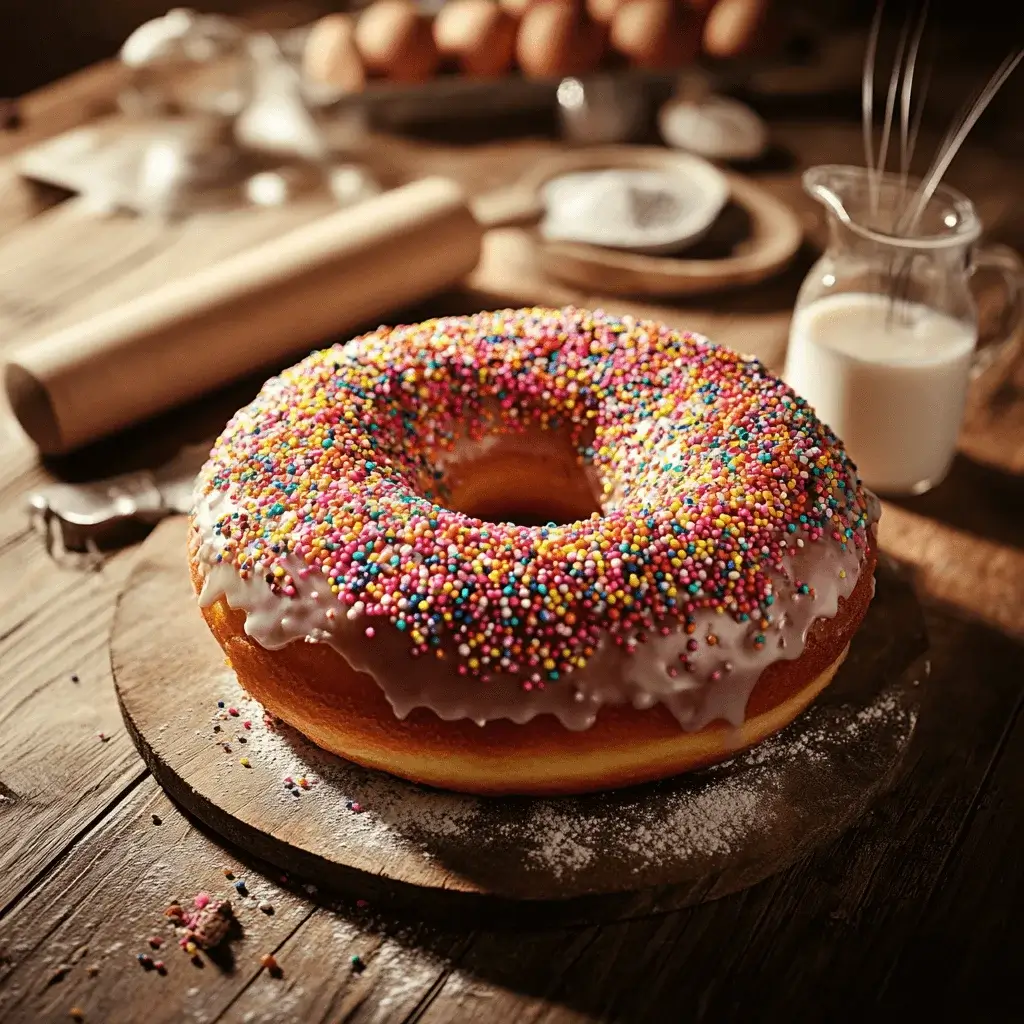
[784,166,1024,495]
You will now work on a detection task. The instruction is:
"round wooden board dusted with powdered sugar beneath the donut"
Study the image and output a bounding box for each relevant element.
[111,517,927,923]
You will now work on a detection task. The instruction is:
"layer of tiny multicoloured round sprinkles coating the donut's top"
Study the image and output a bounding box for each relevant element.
[199,308,868,689]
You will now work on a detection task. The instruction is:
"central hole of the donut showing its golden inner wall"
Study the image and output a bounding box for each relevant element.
[440,430,603,526]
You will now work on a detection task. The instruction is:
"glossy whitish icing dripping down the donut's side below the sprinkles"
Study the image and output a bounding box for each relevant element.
[194,492,879,731]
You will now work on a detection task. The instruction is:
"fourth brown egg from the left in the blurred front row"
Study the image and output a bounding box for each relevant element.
[515,0,606,78]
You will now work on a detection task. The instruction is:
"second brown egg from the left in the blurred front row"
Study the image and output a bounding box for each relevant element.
[355,0,440,82]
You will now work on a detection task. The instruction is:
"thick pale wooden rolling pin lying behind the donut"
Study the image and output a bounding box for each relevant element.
[4,177,484,455]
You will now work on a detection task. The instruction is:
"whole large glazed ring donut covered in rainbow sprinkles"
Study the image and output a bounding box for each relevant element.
[189,308,877,793]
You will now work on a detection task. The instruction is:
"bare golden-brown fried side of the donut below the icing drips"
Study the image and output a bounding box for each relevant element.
[189,527,876,795]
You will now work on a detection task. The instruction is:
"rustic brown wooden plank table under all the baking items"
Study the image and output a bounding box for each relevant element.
[0,61,1024,1024]
